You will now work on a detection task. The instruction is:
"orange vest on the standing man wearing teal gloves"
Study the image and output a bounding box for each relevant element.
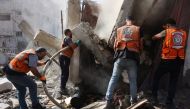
[62,37,77,58]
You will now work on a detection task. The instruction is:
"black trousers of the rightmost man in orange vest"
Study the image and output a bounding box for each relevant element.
[152,59,184,102]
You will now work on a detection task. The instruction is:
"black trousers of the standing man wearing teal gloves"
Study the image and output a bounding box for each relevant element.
[59,55,70,90]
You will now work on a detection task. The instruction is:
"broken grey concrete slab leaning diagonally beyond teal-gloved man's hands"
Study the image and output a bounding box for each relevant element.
[72,23,113,67]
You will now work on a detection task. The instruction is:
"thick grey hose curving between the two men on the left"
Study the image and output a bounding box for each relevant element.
[42,46,69,109]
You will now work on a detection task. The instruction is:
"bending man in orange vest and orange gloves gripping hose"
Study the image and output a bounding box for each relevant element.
[3,47,47,109]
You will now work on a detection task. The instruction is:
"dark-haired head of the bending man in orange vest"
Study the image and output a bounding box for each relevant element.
[35,47,47,60]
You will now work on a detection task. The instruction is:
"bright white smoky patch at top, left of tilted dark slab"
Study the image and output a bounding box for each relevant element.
[95,0,124,41]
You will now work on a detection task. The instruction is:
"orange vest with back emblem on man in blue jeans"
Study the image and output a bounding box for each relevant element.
[114,25,140,52]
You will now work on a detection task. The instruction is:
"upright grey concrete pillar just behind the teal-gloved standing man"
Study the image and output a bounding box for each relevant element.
[66,0,82,84]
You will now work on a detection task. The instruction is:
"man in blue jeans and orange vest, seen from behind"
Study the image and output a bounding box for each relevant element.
[104,17,141,109]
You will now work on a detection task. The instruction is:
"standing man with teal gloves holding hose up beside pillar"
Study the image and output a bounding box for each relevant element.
[59,29,81,95]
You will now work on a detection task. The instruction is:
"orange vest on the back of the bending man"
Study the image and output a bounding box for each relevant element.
[9,49,35,73]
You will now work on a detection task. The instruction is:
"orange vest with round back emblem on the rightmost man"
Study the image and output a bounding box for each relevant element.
[162,27,187,59]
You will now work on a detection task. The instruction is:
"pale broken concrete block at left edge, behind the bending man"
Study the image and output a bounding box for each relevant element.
[0,78,13,93]
